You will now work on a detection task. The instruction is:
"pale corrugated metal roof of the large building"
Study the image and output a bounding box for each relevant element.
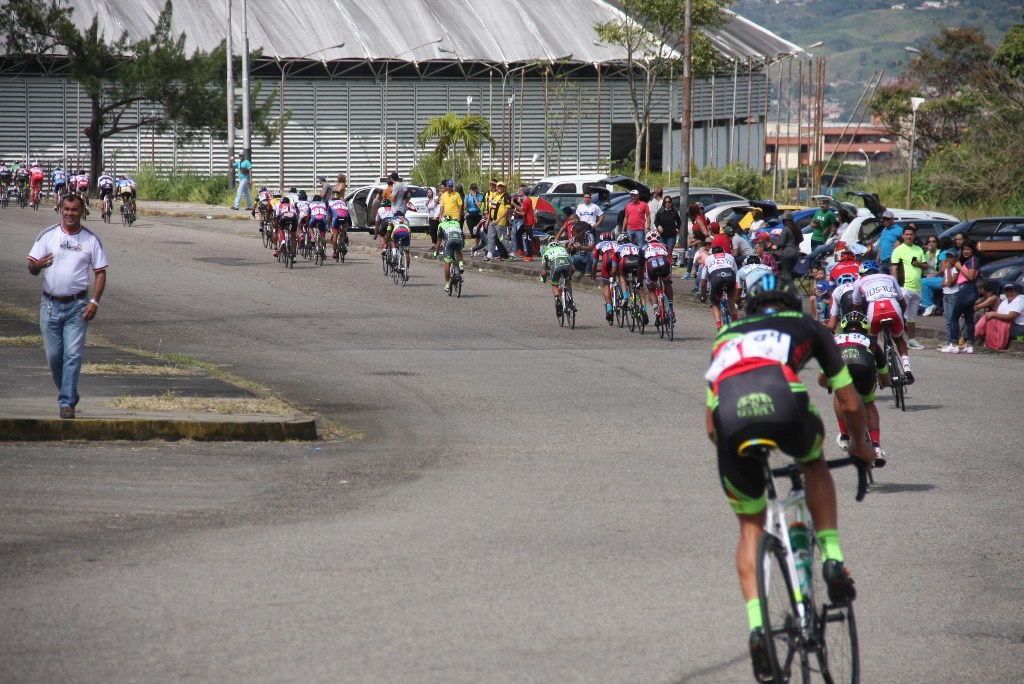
[51,0,800,65]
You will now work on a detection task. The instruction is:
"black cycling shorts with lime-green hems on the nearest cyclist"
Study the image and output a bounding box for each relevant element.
[712,365,824,514]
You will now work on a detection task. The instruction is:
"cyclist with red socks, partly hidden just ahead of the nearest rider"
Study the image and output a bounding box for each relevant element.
[818,311,889,468]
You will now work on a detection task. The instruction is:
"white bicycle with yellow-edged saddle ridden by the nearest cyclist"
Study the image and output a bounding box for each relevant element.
[739,439,867,684]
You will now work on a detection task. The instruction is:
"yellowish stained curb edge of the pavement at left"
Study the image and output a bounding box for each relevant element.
[0,418,317,441]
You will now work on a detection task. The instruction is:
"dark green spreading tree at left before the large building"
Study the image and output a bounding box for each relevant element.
[0,0,283,189]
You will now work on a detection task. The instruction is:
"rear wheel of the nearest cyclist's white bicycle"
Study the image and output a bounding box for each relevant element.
[758,532,800,682]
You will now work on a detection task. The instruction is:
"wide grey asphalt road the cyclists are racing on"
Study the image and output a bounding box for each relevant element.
[0,209,1024,683]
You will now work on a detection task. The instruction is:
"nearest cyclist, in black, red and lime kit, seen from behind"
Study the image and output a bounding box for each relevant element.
[705,274,874,682]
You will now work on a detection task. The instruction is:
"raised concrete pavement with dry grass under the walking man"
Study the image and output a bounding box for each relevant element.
[0,310,316,441]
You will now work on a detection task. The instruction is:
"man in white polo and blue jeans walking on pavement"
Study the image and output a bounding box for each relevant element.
[29,195,106,419]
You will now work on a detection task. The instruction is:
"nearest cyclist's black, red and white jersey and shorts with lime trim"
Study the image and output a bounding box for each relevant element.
[705,311,853,514]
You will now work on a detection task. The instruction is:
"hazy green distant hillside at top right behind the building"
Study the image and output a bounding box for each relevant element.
[732,0,1022,120]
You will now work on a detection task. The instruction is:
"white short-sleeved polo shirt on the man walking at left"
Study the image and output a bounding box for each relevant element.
[29,223,108,297]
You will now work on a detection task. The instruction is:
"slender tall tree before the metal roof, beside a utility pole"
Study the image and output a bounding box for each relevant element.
[594,0,731,177]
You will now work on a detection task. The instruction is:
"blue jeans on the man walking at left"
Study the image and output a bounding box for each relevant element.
[39,297,89,408]
